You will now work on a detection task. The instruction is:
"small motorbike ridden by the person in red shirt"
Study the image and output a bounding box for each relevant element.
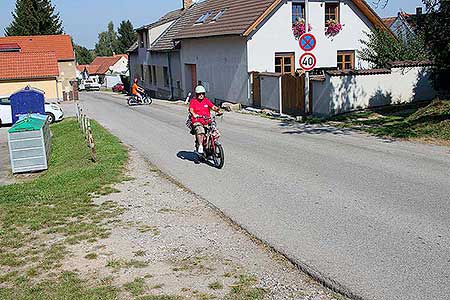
[195,114,225,169]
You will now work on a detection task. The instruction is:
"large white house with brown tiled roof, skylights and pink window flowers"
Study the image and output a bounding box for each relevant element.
[174,0,388,105]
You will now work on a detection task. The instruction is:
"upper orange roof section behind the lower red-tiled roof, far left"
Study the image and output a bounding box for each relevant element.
[0,35,75,61]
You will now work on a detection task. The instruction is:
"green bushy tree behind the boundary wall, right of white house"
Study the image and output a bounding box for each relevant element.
[358,28,429,68]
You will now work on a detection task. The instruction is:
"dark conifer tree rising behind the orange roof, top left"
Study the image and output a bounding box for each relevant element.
[5,0,64,36]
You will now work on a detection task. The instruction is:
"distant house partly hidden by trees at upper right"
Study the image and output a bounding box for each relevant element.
[383,7,425,42]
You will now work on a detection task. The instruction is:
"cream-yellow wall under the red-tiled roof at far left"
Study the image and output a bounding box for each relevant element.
[0,78,62,100]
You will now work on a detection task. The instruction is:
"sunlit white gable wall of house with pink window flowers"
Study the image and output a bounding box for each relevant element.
[248,0,373,72]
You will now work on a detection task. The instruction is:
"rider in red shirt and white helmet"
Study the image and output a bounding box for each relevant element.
[189,85,219,154]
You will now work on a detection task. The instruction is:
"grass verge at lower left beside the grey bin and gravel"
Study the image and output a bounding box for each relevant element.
[0,119,128,300]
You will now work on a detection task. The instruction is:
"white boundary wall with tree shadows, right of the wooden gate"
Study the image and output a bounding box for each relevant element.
[312,67,436,115]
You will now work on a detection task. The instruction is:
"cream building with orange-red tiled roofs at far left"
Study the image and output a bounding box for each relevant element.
[0,35,76,100]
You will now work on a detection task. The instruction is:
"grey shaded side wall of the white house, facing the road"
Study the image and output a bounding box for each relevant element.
[181,37,250,105]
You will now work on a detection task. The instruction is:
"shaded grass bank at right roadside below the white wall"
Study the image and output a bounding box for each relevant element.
[322,100,450,144]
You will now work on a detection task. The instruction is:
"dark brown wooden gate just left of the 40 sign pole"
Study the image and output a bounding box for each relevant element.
[281,74,306,115]
